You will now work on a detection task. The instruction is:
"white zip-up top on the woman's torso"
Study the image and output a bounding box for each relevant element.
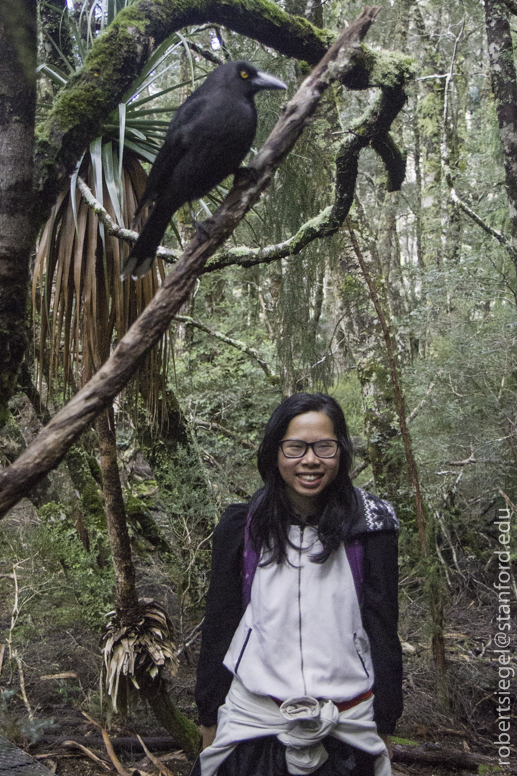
[224,525,373,703]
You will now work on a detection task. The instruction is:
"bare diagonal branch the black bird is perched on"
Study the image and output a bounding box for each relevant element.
[0,6,380,517]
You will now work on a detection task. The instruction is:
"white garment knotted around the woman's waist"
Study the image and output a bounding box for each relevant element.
[200,677,391,776]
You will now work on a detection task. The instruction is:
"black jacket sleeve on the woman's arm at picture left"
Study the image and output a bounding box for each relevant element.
[195,504,247,727]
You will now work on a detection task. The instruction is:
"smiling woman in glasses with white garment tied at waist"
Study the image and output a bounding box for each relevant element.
[193,393,402,776]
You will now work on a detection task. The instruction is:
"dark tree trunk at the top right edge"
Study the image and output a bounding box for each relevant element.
[485,0,517,270]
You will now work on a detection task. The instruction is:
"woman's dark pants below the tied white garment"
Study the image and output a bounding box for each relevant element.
[191,736,375,776]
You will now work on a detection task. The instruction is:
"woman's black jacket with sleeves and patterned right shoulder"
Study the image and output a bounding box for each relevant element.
[196,488,402,734]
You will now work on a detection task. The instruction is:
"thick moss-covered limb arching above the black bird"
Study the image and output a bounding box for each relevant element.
[35,0,411,223]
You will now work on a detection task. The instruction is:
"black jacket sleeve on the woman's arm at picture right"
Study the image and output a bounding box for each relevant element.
[362,531,403,735]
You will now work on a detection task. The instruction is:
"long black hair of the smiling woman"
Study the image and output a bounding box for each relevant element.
[250,393,357,564]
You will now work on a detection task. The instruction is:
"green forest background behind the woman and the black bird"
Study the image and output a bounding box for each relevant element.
[0,0,517,772]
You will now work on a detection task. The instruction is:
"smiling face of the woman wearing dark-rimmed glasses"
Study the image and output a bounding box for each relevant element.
[278,412,340,517]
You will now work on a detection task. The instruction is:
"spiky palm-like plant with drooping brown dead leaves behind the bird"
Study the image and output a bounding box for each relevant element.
[33,0,204,406]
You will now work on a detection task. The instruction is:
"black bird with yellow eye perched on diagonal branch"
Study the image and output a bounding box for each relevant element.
[121,62,287,280]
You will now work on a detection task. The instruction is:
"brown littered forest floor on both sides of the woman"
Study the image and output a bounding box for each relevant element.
[0,500,517,776]
